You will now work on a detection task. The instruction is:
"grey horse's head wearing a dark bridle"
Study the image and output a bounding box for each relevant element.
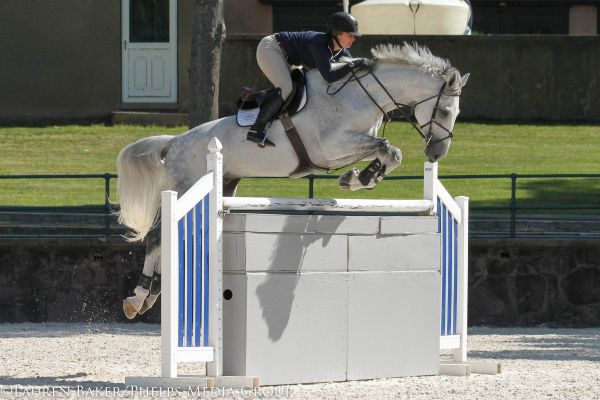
[414,68,469,162]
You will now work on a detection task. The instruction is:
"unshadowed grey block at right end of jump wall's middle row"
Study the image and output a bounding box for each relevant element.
[348,234,440,271]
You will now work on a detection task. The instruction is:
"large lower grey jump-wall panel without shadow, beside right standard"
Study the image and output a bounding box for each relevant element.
[348,271,440,380]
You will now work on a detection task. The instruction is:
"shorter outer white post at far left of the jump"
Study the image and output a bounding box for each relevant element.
[160,190,179,378]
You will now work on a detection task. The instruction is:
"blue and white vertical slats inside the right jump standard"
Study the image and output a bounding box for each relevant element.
[437,198,459,336]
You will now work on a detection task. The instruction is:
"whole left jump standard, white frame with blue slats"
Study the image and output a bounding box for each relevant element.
[161,139,223,378]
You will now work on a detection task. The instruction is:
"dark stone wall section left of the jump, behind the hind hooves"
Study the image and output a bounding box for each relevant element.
[0,238,151,322]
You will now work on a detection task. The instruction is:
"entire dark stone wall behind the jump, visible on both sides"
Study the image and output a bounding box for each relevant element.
[0,239,600,326]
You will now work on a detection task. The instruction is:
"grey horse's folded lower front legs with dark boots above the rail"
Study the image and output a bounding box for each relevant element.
[338,139,402,191]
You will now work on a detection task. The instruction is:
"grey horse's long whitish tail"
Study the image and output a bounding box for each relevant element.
[117,135,174,242]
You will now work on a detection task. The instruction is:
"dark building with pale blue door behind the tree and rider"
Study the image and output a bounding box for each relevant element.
[0,0,600,125]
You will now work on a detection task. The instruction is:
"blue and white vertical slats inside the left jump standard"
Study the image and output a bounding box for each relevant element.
[177,194,210,347]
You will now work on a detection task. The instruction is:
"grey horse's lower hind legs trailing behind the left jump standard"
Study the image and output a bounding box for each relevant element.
[123,223,160,319]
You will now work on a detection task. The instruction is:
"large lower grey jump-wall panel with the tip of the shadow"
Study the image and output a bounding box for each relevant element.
[233,273,347,385]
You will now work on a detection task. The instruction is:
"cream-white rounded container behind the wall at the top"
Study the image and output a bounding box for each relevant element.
[351,0,470,35]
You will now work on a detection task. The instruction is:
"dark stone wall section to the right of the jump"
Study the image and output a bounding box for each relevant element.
[469,239,600,327]
